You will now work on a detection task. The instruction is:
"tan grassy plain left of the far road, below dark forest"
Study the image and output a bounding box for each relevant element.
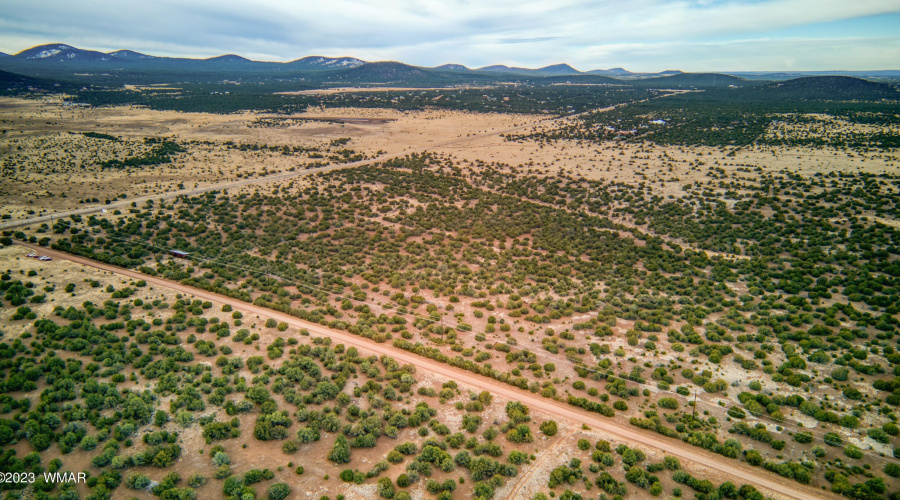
[0,99,536,220]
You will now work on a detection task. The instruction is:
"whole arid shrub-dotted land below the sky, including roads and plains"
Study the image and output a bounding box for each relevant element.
[0,30,900,500]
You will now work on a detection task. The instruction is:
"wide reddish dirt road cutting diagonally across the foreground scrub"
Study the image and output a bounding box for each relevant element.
[16,241,842,500]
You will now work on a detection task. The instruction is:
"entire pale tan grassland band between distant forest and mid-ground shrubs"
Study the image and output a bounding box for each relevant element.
[0,94,900,229]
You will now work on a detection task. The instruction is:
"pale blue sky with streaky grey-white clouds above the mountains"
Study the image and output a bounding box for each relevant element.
[0,0,900,71]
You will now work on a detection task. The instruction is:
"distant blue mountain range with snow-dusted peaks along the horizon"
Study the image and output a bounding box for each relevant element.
[0,43,900,88]
